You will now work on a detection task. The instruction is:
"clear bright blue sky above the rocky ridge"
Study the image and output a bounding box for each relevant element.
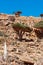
[0,0,43,16]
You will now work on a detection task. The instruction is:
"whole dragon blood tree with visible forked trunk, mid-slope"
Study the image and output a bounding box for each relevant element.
[12,23,32,41]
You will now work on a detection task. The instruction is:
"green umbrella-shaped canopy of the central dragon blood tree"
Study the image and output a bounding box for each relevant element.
[12,23,32,32]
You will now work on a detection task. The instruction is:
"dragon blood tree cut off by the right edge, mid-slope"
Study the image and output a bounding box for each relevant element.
[34,21,43,38]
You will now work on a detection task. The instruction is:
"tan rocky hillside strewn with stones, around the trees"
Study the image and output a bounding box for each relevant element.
[0,14,43,65]
